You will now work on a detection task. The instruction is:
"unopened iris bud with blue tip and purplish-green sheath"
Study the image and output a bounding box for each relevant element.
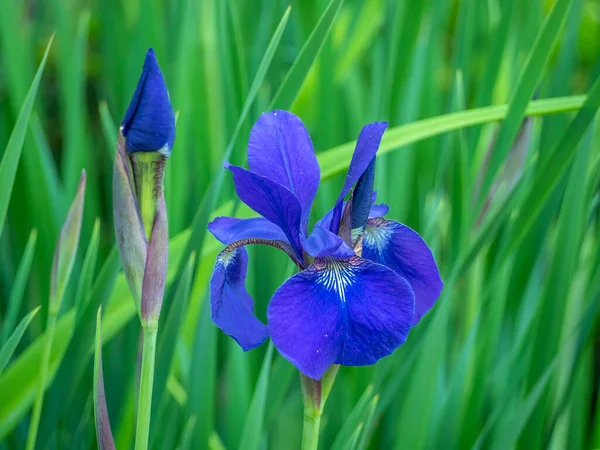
[113,49,175,326]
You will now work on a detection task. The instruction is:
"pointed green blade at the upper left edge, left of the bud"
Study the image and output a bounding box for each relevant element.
[0,37,53,233]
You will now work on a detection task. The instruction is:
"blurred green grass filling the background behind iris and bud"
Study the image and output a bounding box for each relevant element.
[0,0,600,449]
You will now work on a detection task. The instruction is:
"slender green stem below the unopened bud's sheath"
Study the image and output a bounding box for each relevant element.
[135,325,158,450]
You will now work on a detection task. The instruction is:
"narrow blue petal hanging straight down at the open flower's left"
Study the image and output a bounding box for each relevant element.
[210,247,269,351]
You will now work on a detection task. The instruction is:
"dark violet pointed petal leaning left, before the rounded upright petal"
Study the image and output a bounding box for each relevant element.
[227,165,302,260]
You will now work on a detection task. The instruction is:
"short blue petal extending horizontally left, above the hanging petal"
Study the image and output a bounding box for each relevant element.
[208,216,287,245]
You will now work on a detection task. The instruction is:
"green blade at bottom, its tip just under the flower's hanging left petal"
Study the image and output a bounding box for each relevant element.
[239,342,273,450]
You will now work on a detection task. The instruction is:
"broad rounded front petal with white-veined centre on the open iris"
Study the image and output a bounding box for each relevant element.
[267,256,414,379]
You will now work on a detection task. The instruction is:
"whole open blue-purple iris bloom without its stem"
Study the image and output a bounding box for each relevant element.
[208,111,443,379]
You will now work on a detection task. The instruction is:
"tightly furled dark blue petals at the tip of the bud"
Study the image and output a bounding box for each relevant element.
[121,49,175,156]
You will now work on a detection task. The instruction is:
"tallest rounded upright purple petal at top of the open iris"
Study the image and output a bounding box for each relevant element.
[248,111,321,230]
